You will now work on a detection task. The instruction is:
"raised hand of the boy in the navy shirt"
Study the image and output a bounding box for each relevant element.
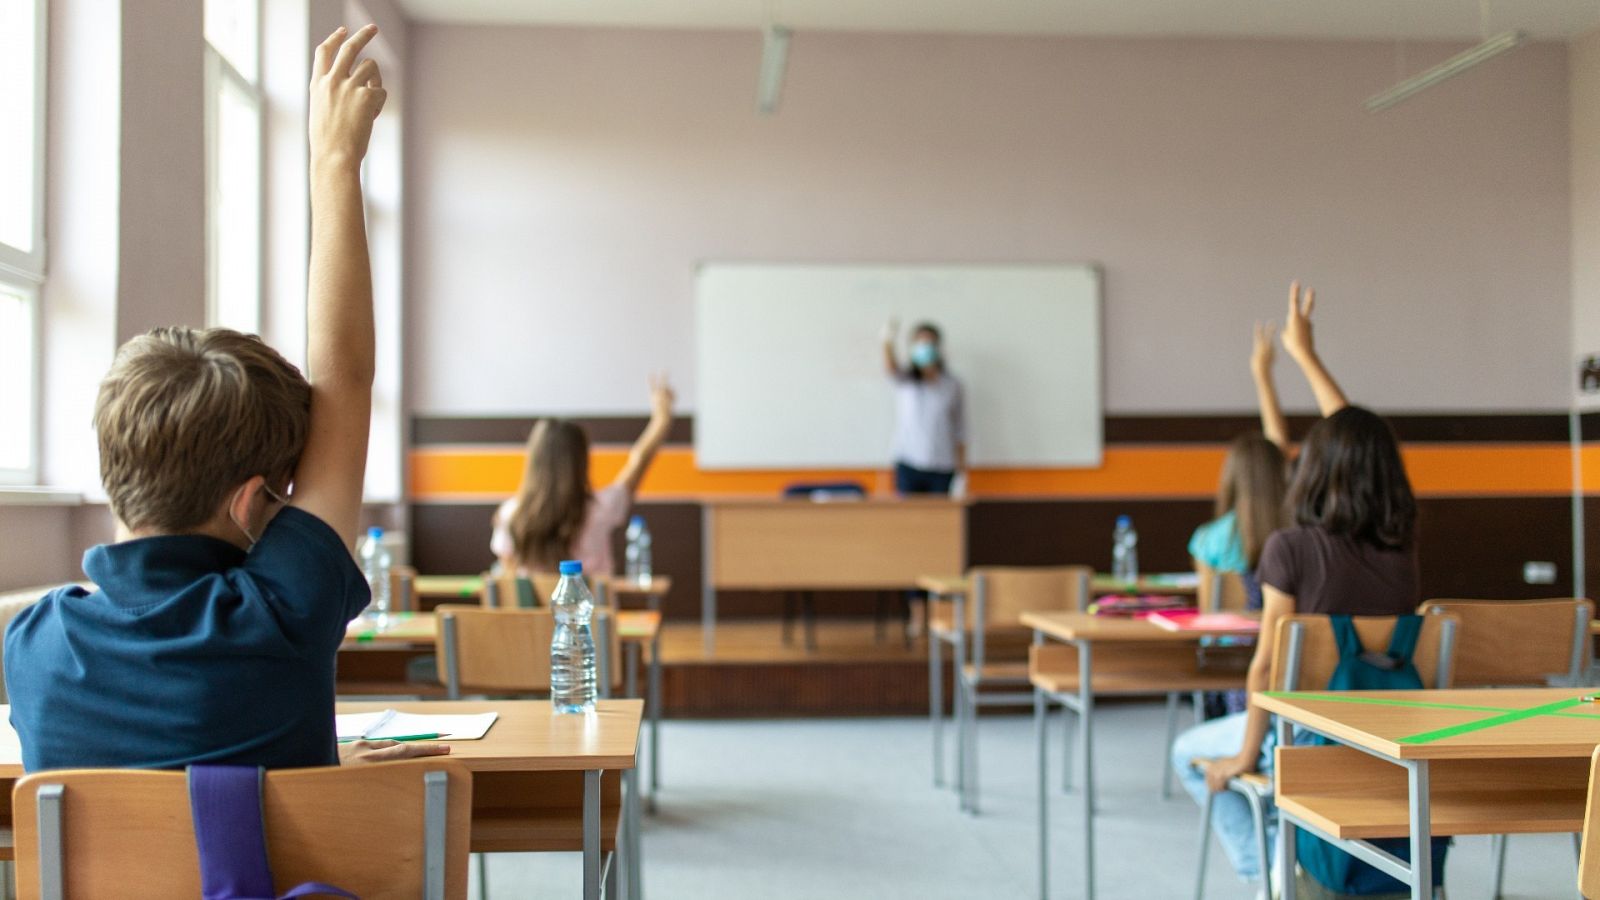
[310,26,389,165]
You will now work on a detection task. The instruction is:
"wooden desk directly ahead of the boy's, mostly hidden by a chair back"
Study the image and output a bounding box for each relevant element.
[339,608,670,812]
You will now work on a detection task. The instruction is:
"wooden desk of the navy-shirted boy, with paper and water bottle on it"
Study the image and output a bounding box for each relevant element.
[0,700,643,900]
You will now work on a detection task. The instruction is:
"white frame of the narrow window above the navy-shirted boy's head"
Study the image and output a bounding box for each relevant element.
[203,2,267,333]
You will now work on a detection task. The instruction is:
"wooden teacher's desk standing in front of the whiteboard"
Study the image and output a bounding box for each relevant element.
[701,498,966,657]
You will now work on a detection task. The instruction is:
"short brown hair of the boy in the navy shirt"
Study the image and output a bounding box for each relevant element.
[94,328,310,532]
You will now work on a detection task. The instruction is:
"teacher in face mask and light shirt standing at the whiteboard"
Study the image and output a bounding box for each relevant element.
[883,319,966,496]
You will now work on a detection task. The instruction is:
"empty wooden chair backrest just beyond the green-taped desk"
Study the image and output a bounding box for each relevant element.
[1422,599,1594,687]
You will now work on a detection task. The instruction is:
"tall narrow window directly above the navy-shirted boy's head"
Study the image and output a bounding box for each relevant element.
[205,0,262,331]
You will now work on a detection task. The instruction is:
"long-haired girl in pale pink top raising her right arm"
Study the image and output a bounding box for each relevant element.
[490,378,674,575]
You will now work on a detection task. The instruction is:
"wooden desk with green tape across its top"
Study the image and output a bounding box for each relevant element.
[1251,687,1600,900]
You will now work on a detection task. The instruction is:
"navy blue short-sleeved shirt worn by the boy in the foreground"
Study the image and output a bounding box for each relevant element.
[5,506,371,772]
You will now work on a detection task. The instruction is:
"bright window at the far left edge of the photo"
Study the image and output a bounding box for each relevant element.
[0,0,46,484]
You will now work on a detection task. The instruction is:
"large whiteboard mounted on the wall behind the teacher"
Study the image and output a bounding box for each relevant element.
[694,263,1101,469]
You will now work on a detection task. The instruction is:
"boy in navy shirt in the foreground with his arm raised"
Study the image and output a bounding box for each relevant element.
[5,26,448,772]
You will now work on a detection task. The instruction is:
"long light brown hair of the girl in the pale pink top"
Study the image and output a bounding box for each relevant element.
[509,420,592,570]
